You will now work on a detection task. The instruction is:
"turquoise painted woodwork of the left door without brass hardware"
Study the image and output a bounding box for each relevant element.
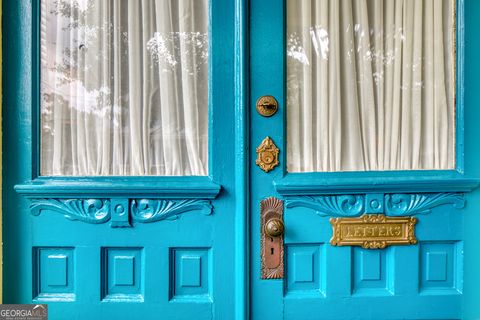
[3,0,238,319]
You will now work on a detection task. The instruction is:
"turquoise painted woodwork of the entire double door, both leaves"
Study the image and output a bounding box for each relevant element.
[3,0,480,320]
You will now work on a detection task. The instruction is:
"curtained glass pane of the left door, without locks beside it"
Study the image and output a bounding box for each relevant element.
[41,0,209,176]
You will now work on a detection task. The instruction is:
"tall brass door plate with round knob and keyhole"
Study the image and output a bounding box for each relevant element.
[260,197,284,279]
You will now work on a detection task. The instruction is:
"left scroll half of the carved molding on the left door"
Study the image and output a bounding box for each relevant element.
[30,199,111,224]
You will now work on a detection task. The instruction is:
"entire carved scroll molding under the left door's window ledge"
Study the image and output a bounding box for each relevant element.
[30,198,213,228]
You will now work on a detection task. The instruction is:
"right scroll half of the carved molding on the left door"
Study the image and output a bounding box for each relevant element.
[130,199,213,223]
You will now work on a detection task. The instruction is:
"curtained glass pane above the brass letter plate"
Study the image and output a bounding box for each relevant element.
[286,0,455,172]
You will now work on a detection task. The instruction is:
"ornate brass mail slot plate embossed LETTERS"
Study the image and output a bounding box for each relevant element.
[330,214,417,249]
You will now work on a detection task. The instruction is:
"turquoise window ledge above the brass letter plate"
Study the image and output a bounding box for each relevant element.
[274,171,480,196]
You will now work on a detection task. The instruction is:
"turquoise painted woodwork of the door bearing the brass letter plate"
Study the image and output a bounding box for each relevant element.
[250,0,479,320]
